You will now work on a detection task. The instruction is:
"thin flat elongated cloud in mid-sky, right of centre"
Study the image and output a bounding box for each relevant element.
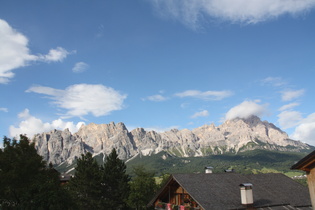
[175,90,232,101]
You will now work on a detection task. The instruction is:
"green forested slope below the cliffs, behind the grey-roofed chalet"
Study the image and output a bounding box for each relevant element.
[127,147,306,175]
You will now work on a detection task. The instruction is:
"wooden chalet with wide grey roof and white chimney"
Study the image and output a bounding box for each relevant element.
[148,173,312,210]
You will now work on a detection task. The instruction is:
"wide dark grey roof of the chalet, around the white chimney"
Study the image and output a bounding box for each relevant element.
[150,173,311,209]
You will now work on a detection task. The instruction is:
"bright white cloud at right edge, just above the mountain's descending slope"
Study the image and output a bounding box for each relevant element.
[290,113,315,145]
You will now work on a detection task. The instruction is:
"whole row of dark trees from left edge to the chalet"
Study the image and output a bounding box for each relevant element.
[0,135,159,210]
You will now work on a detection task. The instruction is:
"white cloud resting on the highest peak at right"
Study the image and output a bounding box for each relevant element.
[225,101,267,120]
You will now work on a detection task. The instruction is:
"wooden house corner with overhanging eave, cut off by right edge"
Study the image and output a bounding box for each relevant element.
[291,151,315,209]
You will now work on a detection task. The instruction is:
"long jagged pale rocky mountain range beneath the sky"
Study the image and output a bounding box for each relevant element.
[34,116,310,164]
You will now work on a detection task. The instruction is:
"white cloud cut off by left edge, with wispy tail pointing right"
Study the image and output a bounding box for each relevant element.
[0,19,69,84]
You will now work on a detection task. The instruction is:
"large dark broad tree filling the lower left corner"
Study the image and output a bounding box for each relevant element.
[0,135,69,209]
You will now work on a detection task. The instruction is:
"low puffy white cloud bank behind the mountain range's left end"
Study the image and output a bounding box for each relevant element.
[9,109,85,138]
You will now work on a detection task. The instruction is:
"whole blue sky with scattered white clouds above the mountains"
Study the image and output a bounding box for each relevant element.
[0,0,315,145]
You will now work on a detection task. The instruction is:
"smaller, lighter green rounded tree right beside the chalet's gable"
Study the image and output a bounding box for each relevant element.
[129,166,157,210]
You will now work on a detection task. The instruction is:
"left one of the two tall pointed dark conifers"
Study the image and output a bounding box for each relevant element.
[69,153,102,209]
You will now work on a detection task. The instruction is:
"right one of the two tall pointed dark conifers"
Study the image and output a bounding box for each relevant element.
[102,149,130,210]
